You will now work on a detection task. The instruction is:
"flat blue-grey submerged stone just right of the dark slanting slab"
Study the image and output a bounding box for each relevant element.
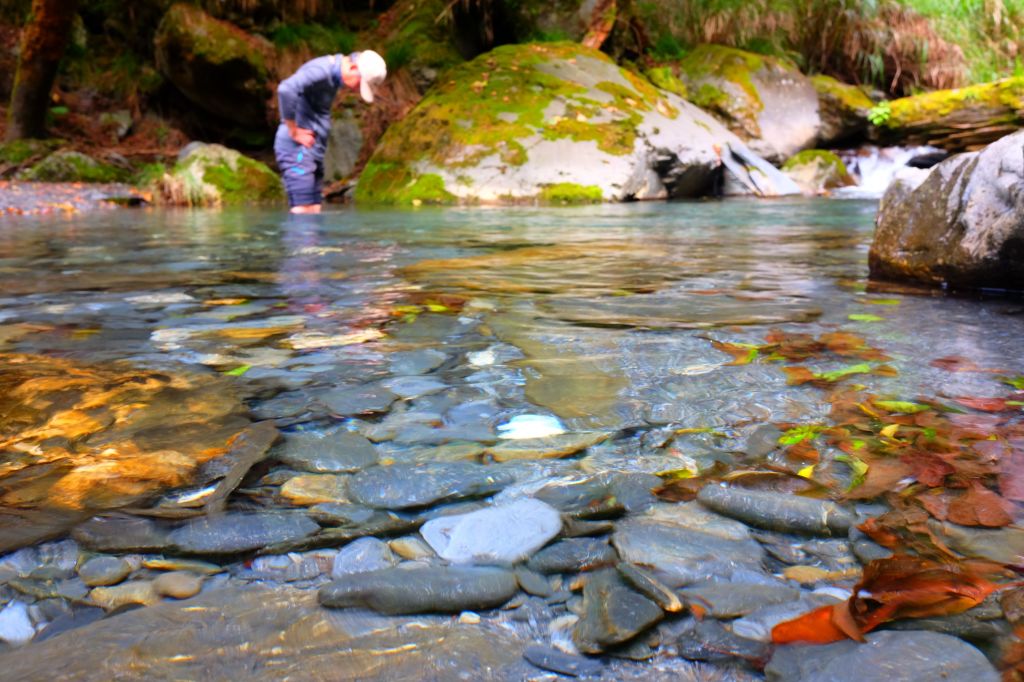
[274,429,378,473]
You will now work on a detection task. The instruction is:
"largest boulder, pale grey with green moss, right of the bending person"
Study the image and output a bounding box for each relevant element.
[355,43,798,204]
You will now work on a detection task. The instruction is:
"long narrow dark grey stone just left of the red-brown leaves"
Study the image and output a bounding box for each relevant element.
[697,483,857,537]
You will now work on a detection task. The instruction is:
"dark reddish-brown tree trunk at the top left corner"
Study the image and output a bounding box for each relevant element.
[6,0,78,141]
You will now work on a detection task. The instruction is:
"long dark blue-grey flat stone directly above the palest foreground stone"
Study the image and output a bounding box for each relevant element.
[348,462,513,509]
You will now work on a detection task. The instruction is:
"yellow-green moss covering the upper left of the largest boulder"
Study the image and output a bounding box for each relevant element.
[355,43,678,204]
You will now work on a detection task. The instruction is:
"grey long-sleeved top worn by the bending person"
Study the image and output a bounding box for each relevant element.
[278,54,342,159]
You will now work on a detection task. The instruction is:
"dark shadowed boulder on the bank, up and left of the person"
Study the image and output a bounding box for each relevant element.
[154,3,275,127]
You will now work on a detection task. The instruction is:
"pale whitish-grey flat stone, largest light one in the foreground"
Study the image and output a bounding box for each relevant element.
[420,498,562,564]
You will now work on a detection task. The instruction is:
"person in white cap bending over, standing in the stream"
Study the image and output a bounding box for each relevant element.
[273,50,387,213]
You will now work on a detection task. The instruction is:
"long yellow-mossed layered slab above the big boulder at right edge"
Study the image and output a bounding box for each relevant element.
[873,77,1024,152]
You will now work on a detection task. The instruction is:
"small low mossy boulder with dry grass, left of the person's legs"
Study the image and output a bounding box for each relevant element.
[153,143,285,207]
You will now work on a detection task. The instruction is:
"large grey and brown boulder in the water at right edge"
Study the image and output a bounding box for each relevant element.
[869,131,1024,290]
